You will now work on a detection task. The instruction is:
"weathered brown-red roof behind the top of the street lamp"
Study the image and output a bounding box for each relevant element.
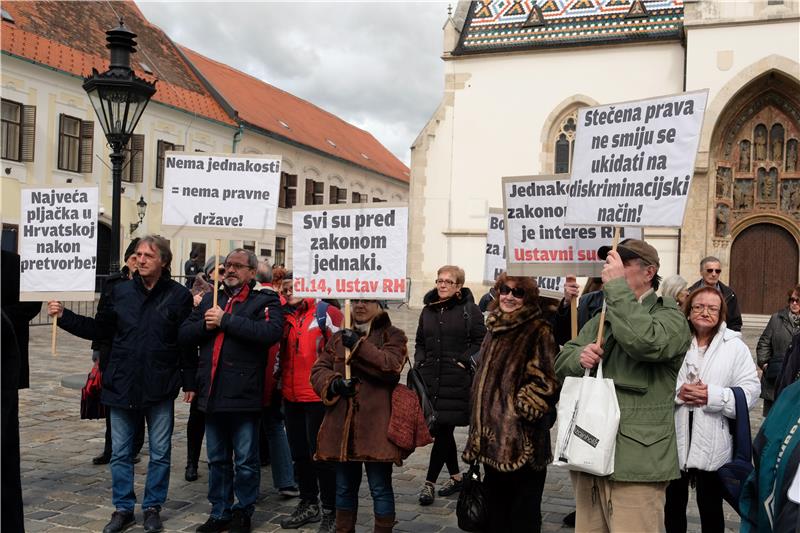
[0,0,236,126]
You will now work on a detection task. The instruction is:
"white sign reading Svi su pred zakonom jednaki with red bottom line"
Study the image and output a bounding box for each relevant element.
[292,203,408,300]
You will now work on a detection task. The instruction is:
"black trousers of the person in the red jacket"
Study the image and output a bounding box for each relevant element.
[283,401,336,510]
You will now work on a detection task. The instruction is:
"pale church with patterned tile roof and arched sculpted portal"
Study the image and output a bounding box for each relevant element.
[409,0,800,314]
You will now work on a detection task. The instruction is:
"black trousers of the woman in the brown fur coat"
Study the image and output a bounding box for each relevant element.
[483,465,547,533]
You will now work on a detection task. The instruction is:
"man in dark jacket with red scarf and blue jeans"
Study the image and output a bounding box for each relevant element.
[180,248,283,533]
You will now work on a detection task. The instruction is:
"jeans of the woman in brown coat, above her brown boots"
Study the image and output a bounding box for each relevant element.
[336,461,394,516]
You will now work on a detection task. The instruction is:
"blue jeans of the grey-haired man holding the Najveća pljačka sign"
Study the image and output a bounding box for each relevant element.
[111,399,175,512]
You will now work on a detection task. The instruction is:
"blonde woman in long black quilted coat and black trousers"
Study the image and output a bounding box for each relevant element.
[414,265,486,505]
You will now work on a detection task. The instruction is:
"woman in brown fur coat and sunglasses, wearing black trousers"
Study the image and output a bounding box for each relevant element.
[462,273,558,533]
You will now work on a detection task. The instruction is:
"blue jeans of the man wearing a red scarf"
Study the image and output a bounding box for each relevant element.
[206,412,261,520]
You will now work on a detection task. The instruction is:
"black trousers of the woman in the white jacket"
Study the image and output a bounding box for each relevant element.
[664,469,725,533]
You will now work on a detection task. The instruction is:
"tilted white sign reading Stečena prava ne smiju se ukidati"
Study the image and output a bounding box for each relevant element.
[566,90,708,227]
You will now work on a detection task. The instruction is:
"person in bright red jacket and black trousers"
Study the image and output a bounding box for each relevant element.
[280,276,342,533]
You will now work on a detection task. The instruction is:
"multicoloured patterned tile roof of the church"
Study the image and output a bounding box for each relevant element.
[453,0,683,55]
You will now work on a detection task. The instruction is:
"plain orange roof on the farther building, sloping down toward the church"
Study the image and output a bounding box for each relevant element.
[181,47,409,183]
